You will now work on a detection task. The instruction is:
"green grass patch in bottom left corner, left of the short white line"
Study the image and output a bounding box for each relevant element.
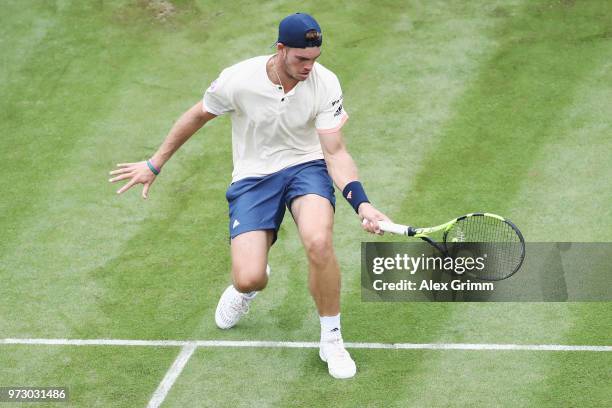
[0,345,177,407]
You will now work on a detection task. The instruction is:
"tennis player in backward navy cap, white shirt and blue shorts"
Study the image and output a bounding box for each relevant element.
[110,13,388,378]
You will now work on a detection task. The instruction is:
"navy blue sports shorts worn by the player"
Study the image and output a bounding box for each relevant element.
[225,159,336,241]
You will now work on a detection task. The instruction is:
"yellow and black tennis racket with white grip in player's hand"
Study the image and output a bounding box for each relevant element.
[378,213,525,281]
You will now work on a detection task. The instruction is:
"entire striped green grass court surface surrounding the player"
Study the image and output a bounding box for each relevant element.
[0,0,612,407]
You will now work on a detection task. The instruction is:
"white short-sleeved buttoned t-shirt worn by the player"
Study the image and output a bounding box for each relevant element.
[204,55,348,182]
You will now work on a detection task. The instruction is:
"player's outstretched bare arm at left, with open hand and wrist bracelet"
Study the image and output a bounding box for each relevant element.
[109,101,216,199]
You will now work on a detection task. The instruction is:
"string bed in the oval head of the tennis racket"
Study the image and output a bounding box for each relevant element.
[445,216,524,280]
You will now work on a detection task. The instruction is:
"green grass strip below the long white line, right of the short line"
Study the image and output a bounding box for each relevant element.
[157,349,611,407]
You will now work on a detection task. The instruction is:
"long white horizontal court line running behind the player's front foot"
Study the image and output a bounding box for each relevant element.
[0,339,612,351]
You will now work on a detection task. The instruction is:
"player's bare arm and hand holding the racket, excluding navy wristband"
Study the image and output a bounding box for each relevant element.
[319,130,390,233]
